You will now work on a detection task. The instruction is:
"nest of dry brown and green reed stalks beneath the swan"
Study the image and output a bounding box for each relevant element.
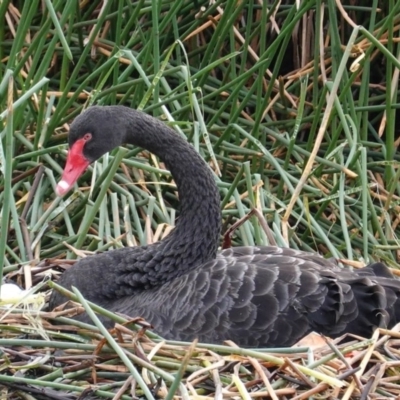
[0,294,400,400]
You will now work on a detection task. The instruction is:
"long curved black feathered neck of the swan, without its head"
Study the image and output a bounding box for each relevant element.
[115,109,221,288]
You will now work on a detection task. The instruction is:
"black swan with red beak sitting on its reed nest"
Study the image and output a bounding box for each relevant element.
[49,106,400,347]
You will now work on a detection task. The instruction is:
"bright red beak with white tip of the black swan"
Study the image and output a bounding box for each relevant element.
[56,139,90,196]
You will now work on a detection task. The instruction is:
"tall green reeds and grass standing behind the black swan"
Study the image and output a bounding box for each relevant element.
[0,0,400,396]
